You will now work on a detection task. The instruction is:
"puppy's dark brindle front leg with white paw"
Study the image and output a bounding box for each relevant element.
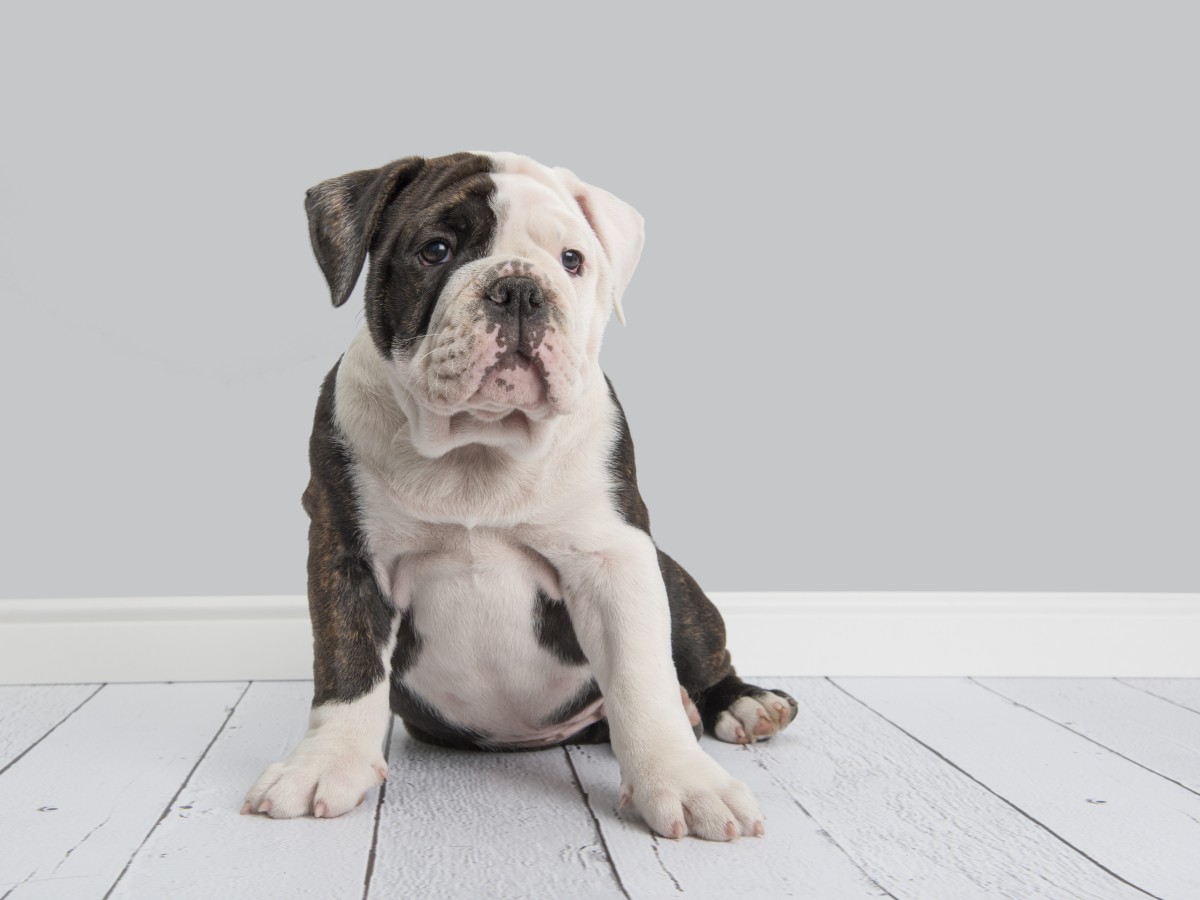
[242,513,398,818]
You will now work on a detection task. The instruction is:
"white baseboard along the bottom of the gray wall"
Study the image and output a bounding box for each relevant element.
[0,593,1200,684]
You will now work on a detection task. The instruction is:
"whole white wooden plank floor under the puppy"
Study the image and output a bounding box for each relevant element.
[0,678,1200,900]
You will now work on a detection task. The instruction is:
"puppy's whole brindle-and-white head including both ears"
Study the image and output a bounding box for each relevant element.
[306,154,643,425]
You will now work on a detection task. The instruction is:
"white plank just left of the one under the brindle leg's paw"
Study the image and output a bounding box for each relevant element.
[0,683,245,900]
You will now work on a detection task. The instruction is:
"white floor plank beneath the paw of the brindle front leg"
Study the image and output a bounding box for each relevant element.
[105,682,378,900]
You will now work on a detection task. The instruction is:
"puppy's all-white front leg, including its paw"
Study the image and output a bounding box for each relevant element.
[554,528,763,840]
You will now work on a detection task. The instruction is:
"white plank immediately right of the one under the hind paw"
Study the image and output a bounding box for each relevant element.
[838,678,1200,898]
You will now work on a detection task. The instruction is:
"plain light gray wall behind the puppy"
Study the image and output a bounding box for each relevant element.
[0,2,1200,596]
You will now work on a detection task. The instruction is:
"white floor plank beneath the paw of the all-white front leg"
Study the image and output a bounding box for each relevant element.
[569,734,882,900]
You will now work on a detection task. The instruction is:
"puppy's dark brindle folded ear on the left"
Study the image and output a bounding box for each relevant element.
[304,156,425,306]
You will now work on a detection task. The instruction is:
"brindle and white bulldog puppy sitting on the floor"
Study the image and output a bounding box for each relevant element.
[242,154,797,840]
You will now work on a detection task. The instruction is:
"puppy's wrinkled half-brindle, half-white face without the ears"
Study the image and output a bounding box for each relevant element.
[381,157,611,419]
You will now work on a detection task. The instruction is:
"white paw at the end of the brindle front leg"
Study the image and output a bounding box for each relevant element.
[241,742,388,818]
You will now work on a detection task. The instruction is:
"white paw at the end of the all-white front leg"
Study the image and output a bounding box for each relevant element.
[620,749,763,841]
